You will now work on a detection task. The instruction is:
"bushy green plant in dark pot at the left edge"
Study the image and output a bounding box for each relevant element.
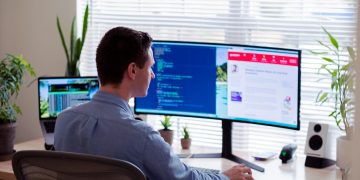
[0,54,36,160]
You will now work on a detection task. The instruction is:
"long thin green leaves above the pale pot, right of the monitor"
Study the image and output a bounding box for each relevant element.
[311,27,356,135]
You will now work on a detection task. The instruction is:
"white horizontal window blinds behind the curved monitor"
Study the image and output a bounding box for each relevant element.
[77,0,357,157]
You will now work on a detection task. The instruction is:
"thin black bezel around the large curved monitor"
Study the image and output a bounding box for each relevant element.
[134,40,301,130]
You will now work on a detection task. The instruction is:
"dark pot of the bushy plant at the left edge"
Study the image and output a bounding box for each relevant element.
[0,123,16,161]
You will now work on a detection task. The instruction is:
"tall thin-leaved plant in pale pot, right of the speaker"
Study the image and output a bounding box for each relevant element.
[312,28,356,170]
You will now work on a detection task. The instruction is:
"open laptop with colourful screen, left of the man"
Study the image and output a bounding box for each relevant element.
[38,77,99,146]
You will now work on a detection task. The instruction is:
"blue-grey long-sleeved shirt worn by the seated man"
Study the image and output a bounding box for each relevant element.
[55,91,228,180]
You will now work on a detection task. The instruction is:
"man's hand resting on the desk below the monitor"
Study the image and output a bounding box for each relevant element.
[223,164,254,180]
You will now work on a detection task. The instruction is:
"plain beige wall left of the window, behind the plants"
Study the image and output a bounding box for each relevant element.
[0,0,76,142]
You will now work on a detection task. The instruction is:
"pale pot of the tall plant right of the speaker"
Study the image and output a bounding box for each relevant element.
[336,136,351,171]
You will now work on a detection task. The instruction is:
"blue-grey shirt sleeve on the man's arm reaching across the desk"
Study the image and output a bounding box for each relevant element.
[143,131,228,180]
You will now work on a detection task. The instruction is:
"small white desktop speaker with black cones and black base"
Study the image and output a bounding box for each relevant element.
[305,122,335,168]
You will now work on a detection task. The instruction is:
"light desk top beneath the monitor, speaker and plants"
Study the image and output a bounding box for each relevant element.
[0,139,341,180]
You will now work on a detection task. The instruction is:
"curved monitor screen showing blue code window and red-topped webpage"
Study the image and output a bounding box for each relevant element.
[135,41,301,129]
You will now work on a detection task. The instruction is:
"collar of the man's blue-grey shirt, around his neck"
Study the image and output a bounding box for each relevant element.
[93,91,133,115]
